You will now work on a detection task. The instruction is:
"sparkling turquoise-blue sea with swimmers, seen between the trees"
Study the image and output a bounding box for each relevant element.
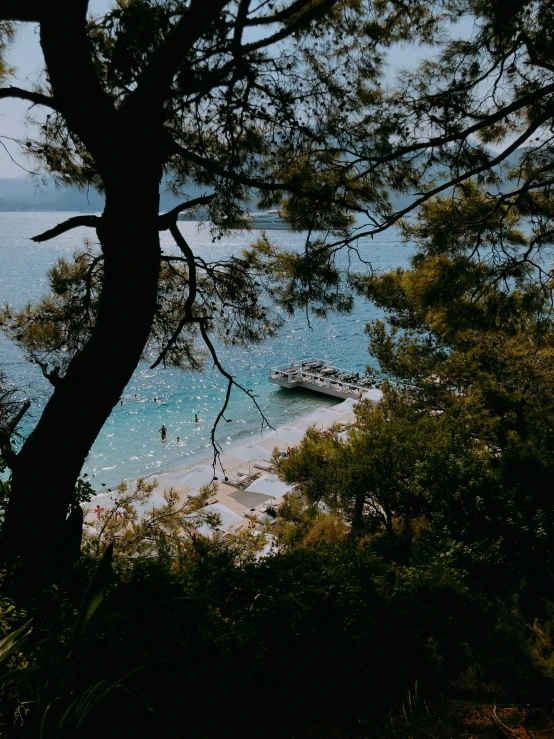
[0,213,411,487]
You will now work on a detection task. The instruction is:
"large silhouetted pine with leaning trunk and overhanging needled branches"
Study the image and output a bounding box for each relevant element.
[0,0,554,580]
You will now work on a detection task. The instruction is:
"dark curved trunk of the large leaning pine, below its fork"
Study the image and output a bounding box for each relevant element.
[0,178,160,571]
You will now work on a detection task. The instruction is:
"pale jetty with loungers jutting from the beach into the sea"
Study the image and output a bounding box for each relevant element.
[268,358,381,400]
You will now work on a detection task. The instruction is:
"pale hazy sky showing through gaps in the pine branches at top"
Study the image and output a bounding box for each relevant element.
[0,0,466,177]
